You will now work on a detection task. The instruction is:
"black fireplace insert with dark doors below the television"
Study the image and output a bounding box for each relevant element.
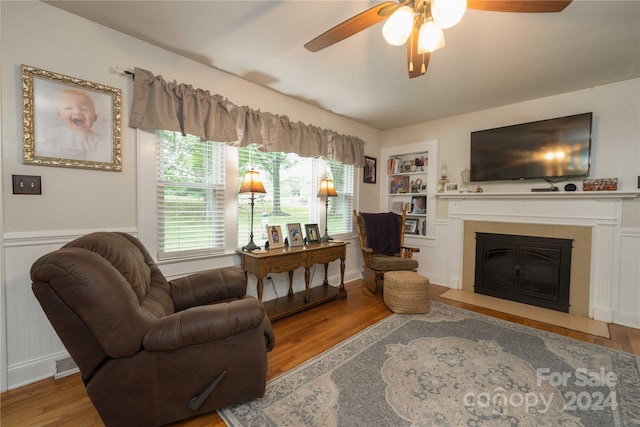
[474,232,573,313]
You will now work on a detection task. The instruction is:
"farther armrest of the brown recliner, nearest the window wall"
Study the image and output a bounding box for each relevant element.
[169,266,247,311]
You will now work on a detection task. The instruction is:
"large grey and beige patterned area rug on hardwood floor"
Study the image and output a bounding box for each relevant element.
[219,302,640,427]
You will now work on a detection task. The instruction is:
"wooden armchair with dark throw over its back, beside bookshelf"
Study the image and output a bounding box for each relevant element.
[353,210,420,293]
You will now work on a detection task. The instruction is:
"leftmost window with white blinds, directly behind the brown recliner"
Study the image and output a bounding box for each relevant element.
[156,131,225,259]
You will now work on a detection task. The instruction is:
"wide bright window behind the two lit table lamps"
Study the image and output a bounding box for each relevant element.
[238,145,355,247]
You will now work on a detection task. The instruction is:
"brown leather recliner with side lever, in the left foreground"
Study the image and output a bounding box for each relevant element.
[31,232,274,426]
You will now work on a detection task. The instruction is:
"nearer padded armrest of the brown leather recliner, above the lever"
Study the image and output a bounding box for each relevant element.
[142,296,265,351]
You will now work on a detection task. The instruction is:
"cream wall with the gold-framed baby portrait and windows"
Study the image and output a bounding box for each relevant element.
[0,1,380,390]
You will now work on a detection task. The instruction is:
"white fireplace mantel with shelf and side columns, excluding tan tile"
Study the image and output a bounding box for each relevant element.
[438,191,640,322]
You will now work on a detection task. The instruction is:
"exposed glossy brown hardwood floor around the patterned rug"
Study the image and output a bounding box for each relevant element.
[0,280,640,427]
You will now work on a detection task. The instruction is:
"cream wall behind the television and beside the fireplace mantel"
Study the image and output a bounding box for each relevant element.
[381,79,640,328]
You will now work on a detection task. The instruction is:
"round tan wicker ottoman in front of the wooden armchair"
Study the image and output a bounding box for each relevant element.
[383,271,429,313]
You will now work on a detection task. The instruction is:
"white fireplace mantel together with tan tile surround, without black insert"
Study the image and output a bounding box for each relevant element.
[439,191,638,322]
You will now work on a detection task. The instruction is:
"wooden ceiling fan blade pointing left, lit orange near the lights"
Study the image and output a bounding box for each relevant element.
[304,1,399,52]
